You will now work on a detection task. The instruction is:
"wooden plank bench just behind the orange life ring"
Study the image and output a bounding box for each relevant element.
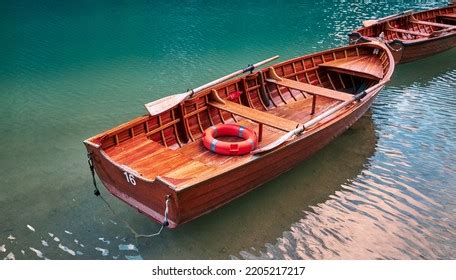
[208,101,299,132]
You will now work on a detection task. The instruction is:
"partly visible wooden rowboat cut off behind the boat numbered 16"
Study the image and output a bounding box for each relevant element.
[349,4,456,63]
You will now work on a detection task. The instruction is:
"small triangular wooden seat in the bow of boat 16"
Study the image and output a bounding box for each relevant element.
[319,55,383,80]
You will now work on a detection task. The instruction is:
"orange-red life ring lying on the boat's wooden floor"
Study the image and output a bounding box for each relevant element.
[203,124,258,155]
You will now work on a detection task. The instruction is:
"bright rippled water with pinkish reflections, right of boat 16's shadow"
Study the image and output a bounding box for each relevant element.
[240,68,456,259]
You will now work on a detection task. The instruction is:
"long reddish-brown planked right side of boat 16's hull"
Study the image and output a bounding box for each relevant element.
[173,89,376,223]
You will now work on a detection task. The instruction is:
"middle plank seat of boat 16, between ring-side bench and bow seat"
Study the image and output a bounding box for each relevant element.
[266,67,353,101]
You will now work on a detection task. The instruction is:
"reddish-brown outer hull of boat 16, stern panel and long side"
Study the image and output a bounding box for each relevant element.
[85,88,381,228]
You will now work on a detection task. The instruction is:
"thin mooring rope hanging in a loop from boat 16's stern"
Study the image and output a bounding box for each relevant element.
[87,153,171,239]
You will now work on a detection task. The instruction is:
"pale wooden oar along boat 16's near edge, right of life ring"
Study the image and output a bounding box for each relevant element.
[252,80,389,154]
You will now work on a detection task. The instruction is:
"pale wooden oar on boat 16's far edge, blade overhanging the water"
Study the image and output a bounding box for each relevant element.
[144,55,279,116]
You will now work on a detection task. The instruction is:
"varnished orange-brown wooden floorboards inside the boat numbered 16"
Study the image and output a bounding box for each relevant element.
[105,92,340,188]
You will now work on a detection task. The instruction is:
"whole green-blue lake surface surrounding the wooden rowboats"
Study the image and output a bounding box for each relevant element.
[0,0,456,259]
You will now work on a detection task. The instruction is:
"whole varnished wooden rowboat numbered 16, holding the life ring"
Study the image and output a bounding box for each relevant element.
[84,42,394,228]
